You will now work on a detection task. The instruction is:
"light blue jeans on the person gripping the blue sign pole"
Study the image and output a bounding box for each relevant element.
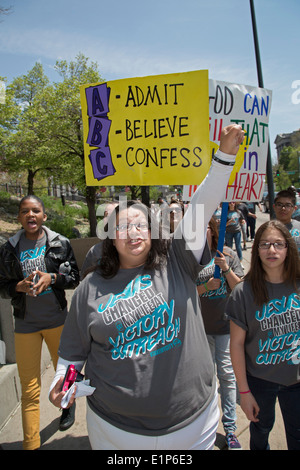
[207,334,237,434]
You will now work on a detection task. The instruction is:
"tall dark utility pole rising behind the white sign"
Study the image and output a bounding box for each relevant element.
[250,0,275,219]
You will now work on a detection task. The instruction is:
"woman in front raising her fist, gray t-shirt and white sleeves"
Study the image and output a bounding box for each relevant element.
[49,125,244,450]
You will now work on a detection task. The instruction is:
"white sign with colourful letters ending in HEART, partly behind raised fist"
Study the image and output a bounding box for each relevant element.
[183,80,272,202]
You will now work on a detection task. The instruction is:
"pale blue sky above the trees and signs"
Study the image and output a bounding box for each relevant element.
[0,0,300,161]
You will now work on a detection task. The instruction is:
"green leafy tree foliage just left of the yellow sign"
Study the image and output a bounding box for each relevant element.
[0,54,101,193]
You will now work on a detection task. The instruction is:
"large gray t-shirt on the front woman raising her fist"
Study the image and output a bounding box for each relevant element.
[59,240,215,435]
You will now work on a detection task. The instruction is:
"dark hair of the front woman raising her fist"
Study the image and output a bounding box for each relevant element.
[98,201,170,278]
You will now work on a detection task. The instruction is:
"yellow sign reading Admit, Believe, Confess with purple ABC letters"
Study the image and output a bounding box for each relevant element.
[81,71,210,186]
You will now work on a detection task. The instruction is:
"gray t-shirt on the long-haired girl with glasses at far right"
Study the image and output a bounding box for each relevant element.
[226,281,300,386]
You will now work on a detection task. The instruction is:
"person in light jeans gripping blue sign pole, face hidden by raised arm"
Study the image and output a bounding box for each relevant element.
[197,217,244,450]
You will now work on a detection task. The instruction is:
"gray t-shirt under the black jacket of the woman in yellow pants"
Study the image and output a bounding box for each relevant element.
[15,234,66,333]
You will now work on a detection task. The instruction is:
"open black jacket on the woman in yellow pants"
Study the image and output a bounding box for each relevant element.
[0,226,79,318]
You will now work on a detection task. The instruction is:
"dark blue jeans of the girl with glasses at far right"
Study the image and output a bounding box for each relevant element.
[247,376,300,450]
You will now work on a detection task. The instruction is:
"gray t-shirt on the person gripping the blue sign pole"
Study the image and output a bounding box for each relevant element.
[197,247,244,335]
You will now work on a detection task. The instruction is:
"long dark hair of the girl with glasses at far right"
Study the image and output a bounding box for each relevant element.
[245,220,300,305]
